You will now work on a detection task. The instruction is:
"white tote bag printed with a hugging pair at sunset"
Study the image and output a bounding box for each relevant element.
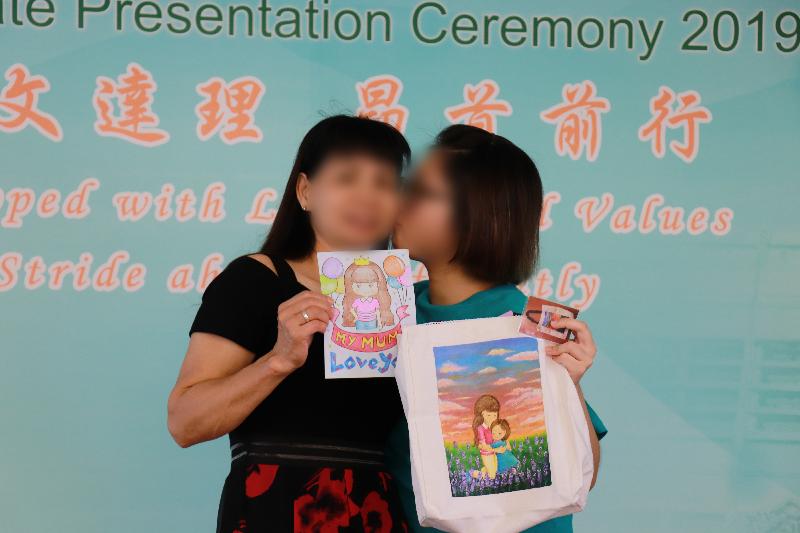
[396,316,594,533]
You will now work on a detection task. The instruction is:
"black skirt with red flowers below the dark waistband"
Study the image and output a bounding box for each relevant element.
[217,442,408,533]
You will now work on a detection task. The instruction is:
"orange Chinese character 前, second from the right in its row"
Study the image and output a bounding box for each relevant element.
[540,80,611,161]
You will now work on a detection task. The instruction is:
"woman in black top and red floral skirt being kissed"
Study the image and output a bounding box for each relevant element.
[168,115,410,533]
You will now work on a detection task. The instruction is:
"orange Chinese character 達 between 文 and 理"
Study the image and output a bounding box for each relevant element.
[93,63,169,146]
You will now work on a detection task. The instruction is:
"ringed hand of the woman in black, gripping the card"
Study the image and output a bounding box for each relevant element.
[269,290,334,374]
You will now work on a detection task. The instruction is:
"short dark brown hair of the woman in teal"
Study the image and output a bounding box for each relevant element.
[432,124,543,284]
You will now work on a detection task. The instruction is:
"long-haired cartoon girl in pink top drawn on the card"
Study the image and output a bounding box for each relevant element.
[342,257,394,331]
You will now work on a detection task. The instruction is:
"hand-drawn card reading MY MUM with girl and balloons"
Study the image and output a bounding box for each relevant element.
[317,250,417,379]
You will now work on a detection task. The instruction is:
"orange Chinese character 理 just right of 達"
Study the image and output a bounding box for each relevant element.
[195,76,265,144]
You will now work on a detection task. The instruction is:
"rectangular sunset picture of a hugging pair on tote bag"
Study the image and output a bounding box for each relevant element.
[433,337,551,496]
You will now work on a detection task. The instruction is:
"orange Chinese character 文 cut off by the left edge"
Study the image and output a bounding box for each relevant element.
[0,63,64,141]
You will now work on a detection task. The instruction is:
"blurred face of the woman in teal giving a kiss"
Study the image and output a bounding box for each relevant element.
[392,151,457,268]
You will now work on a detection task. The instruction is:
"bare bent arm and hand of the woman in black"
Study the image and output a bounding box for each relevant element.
[167,291,331,448]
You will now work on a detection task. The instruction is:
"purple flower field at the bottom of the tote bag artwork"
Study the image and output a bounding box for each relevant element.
[445,434,551,497]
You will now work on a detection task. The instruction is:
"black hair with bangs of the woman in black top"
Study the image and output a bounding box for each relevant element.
[260,114,411,259]
